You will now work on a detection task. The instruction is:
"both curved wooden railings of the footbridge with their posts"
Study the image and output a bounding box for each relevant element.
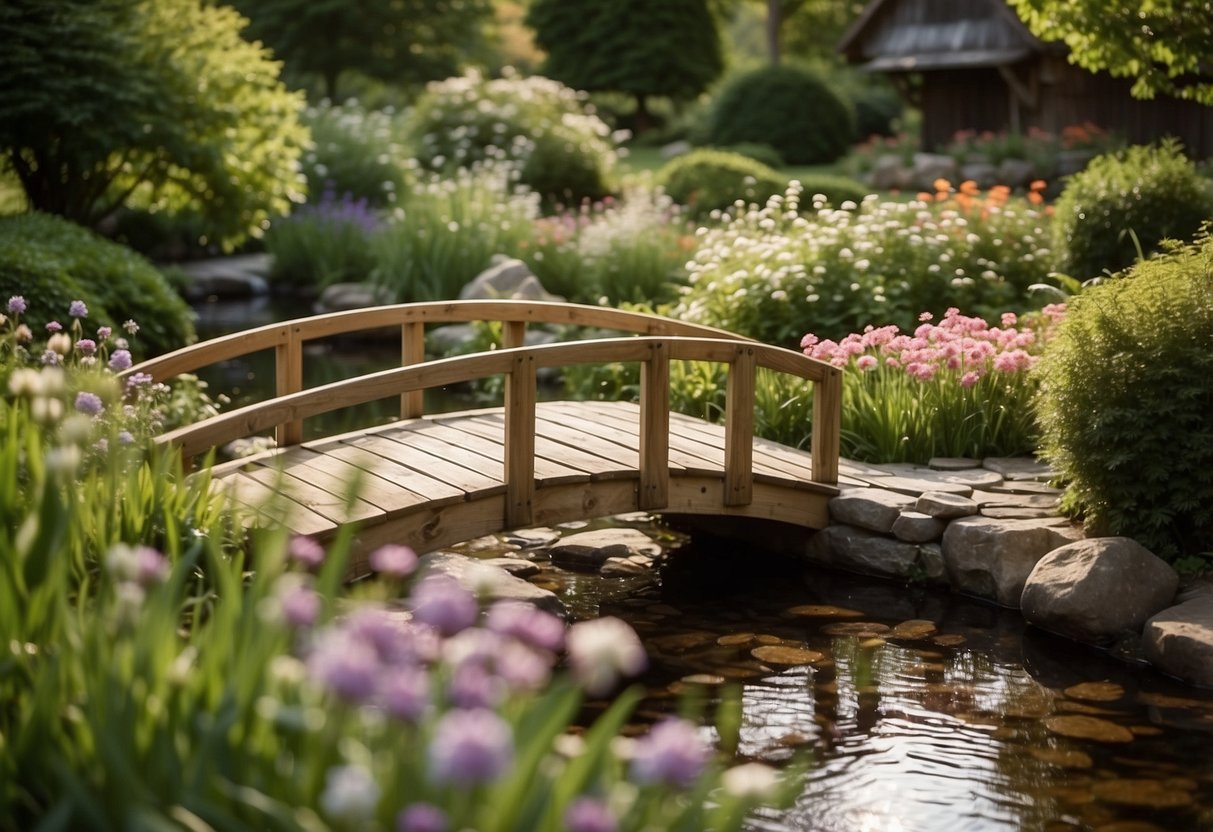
[127,301,842,526]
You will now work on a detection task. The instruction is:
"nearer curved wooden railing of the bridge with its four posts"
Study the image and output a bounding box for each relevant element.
[156,332,842,526]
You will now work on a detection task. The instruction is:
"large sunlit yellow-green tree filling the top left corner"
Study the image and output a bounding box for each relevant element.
[0,0,307,251]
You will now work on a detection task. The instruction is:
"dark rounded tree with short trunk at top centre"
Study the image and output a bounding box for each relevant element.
[526,0,724,130]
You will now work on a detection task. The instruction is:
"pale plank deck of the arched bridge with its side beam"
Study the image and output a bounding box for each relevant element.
[213,401,838,577]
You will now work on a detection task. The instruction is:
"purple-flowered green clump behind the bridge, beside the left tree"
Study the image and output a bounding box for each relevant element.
[266,190,381,290]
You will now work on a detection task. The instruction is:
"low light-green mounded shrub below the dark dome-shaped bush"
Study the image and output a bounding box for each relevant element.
[657,149,787,218]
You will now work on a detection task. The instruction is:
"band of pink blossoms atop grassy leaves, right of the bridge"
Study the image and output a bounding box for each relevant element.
[801,303,1065,387]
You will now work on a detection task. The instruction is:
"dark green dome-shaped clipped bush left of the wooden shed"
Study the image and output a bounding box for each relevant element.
[706,67,855,165]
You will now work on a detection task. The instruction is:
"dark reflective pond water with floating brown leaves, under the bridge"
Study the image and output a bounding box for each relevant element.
[191,302,1213,832]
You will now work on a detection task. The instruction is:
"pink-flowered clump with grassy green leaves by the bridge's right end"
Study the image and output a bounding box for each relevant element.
[801,306,1065,465]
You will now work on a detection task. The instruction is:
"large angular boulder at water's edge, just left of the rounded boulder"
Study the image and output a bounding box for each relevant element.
[943,517,1082,608]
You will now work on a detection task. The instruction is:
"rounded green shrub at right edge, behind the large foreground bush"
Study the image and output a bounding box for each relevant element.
[1053,139,1213,280]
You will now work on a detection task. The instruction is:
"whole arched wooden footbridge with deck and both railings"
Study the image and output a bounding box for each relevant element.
[127,301,842,571]
